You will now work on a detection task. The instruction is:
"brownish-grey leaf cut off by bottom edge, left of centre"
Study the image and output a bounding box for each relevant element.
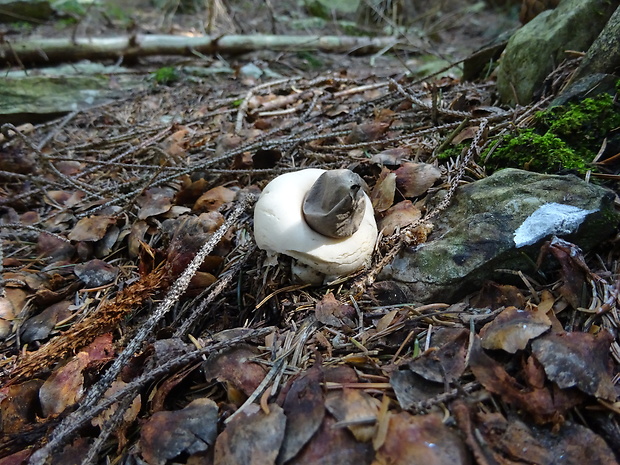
[215,404,286,465]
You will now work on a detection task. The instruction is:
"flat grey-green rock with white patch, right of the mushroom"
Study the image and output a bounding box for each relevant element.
[378,169,620,303]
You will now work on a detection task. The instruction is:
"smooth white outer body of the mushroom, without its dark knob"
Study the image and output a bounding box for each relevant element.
[254,169,377,276]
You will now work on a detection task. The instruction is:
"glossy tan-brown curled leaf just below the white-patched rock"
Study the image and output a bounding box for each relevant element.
[480,307,551,354]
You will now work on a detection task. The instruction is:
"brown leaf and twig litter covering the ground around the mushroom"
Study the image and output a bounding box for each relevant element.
[0,34,620,464]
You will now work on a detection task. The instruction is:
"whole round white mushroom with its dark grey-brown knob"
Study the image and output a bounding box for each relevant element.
[254,168,377,277]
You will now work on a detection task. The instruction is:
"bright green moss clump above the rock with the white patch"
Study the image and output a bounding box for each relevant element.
[482,89,620,174]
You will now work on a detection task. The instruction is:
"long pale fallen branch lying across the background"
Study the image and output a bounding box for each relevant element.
[0,34,398,64]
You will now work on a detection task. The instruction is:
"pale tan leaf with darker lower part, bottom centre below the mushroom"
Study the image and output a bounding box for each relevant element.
[325,388,379,442]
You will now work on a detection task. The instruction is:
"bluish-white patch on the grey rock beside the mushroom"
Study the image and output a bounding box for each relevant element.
[514,202,598,247]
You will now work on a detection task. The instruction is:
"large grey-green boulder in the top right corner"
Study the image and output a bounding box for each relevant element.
[497,0,618,105]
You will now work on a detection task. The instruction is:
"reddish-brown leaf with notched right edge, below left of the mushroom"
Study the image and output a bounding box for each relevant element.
[203,345,266,396]
